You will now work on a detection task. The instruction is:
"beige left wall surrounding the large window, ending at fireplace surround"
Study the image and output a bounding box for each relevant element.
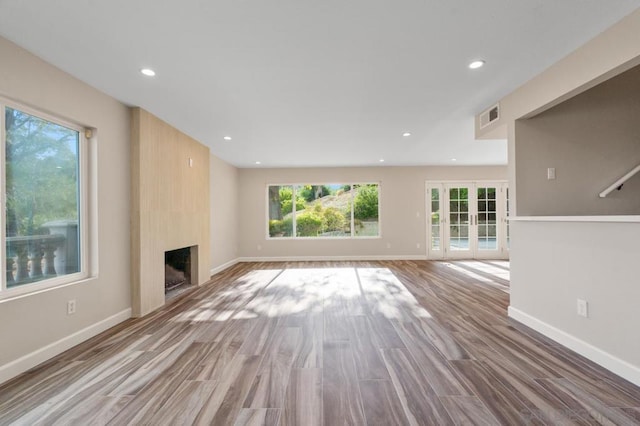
[0,38,131,382]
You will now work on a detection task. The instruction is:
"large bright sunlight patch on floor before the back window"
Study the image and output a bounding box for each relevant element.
[174,267,431,322]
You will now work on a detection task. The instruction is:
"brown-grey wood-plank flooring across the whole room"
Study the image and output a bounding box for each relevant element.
[0,261,640,426]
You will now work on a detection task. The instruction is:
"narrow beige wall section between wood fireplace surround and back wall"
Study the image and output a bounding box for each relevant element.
[209,155,239,273]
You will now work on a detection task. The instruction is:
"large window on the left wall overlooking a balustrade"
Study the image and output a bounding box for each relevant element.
[0,100,86,298]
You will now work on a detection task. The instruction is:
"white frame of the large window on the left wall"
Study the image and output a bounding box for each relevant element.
[0,96,92,302]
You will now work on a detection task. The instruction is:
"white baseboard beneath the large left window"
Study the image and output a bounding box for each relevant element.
[0,308,131,384]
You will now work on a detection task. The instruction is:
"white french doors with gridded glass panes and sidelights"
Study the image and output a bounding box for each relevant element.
[427,182,509,259]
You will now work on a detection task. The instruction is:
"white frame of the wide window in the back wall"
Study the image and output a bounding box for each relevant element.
[264,181,382,241]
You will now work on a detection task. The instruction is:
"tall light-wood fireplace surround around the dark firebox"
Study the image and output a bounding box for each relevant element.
[131,108,210,316]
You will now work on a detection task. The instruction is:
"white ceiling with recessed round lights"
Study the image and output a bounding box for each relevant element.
[0,0,640,167]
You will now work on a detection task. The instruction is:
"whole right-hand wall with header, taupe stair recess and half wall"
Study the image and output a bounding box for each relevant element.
[476,10,640,385]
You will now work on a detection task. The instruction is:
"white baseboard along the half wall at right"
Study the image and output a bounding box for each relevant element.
[509,306,640,386]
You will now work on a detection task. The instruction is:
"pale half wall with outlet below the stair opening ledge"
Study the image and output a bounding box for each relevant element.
[510,222,640,385]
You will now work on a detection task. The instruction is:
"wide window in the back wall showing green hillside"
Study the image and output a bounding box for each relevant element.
[267,183,380,238]
